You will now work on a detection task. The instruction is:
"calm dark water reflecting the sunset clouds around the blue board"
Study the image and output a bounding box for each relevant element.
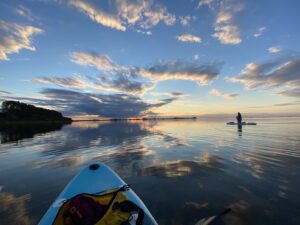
[0,118,300,225]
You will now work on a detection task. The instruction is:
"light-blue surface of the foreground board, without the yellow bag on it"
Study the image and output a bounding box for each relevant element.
[39,163,157,225]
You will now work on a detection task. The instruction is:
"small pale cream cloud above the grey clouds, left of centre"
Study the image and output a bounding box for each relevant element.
[70,52,126,71]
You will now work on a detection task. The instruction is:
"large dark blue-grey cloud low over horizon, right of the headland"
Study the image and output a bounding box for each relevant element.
[38,88,177,118]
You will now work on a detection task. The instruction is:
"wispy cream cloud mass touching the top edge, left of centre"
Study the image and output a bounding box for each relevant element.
[69,0,176,32]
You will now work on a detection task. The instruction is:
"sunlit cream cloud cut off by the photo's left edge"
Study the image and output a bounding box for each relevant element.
[0,20,43,60]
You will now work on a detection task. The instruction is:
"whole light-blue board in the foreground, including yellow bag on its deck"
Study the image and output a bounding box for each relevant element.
[39,163,157,225]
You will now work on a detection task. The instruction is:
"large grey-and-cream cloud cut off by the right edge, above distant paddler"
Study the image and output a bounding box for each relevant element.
[229,56,300,97]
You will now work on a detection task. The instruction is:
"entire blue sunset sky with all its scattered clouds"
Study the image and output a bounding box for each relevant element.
[0,0,300,117]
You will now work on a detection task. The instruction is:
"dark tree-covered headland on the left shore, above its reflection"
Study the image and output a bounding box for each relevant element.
[0,101,72,123]
